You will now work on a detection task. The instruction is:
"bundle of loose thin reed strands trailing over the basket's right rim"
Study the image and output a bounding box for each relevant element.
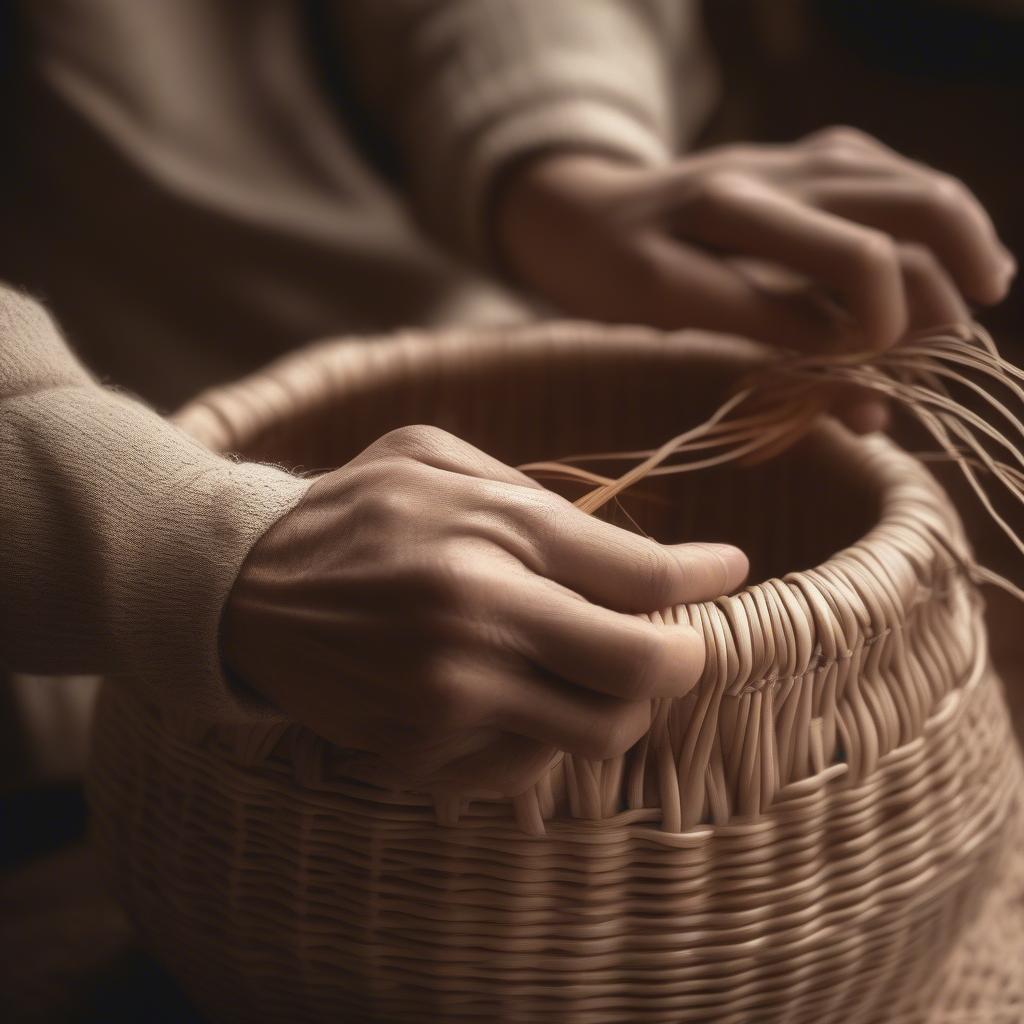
[520,324,1024,596]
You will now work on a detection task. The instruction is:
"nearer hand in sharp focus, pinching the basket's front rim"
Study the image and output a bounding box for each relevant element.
[221,427,746,796]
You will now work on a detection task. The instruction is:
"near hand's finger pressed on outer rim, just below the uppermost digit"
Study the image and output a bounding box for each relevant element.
[495,573,705,700]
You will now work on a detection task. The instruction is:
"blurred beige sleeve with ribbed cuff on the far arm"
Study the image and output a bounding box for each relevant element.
[333,0,715,264]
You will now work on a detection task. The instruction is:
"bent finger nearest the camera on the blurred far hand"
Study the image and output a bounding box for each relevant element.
[675,174,909,347]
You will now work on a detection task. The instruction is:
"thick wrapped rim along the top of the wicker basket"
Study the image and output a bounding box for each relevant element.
[175,321,973,692]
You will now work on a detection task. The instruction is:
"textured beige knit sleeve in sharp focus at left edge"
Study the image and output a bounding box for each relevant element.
[0,288,309,719]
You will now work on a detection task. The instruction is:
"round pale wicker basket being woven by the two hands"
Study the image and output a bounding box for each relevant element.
[90,325,1024,1024]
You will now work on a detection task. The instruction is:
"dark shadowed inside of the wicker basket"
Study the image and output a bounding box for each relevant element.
[224,341,881,582]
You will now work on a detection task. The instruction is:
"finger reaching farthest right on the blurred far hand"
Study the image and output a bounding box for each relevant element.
[800,174,1015,306]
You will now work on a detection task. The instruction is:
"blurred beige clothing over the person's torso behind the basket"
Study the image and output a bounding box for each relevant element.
[0,0,525,408]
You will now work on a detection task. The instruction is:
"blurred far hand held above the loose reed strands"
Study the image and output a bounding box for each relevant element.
[494,128,1016,428]
